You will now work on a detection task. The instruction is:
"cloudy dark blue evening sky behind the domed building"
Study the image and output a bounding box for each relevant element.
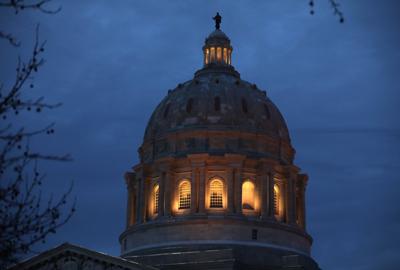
[0,0,400,270]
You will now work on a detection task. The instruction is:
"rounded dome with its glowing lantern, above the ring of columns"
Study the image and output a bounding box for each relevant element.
[139,19,294,163]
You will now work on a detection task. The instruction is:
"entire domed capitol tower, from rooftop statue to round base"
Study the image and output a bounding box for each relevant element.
[120,13,319,270]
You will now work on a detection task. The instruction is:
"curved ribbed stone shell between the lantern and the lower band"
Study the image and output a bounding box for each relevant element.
[144,73,290,142]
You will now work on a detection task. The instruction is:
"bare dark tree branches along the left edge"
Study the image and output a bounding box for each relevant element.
[0,0,75,269]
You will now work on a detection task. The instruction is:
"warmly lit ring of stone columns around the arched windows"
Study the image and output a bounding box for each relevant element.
[126,162,307,229]
